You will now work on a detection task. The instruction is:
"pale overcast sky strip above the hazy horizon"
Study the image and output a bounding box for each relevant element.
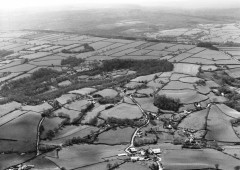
[0,0,240,11]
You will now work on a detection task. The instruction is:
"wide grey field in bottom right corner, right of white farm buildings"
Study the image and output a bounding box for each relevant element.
[162,149,239,170]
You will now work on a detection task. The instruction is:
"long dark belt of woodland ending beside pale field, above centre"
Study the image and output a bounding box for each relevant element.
[98,59,174,75]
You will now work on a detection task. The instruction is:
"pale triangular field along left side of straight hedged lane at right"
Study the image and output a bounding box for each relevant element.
[178,109,208,130]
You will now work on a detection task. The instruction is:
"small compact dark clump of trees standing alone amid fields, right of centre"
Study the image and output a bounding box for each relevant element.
[153,95,181,112]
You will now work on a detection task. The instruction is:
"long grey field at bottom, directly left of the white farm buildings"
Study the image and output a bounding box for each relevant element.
[48,145,126,169]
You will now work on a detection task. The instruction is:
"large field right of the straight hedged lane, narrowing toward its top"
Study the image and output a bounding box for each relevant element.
[206,106,240,142]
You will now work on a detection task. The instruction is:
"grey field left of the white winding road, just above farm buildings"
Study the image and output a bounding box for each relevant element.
[95,127,135,145]
